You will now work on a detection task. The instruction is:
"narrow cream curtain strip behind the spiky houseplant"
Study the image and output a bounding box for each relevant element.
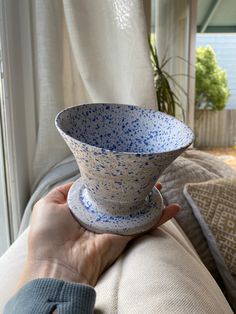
[155,0,190,122]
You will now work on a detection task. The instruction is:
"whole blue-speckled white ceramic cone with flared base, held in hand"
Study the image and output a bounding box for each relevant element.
[56,103,194,234]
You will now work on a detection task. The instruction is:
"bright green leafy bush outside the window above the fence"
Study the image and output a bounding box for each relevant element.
[195,46,230,110]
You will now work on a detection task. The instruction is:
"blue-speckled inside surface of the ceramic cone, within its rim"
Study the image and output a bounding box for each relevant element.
[56,104,193,153]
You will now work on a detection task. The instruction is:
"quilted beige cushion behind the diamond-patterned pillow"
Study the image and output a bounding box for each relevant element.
[159,149,236,289]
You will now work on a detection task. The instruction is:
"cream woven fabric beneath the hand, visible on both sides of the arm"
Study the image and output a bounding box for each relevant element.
[0,221,233,314]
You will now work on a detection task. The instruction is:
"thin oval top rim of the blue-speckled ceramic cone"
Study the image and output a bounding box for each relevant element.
[54,102,195,156]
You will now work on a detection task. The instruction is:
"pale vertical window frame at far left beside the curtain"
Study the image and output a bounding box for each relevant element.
[0,0,36,242]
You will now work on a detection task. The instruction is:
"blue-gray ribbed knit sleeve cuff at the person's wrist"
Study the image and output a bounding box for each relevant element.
[3,278,96,314]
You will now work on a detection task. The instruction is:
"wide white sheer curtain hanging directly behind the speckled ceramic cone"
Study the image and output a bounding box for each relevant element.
[31,0,156,182]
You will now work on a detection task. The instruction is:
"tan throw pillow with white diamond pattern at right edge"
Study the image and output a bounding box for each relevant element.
[184,178,236,306]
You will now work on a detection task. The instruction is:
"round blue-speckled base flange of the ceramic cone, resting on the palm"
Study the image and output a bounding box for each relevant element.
[68,178,164,235]
